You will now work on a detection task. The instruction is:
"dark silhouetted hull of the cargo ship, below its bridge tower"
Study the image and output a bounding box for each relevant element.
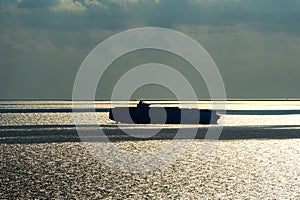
[109,107,220,124]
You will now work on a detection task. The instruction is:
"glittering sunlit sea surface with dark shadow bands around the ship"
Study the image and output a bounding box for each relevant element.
[0,101,300,199]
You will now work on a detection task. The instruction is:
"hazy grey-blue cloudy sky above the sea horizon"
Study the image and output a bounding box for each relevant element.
[0,0,300,99]
